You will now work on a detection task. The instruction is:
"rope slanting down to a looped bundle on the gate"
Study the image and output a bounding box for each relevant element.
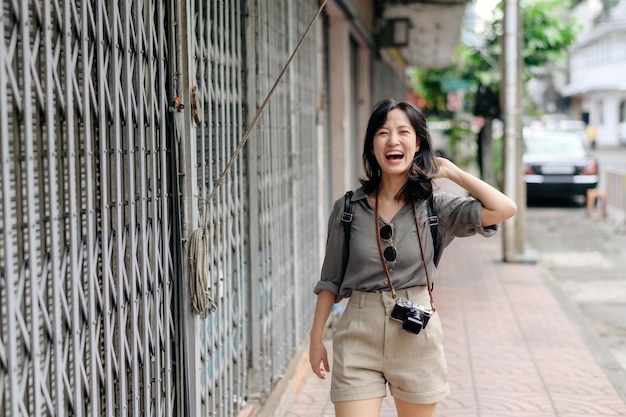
[189,0,327,316]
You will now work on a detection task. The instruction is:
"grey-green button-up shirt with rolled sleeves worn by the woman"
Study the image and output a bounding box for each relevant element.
[314,188,497,302]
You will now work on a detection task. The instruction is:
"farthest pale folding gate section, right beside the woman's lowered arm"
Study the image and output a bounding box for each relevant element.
[239,0,322,396]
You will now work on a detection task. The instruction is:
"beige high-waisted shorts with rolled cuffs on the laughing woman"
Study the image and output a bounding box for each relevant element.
[330,286,450,404]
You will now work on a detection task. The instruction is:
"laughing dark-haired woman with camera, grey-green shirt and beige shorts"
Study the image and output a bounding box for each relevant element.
[309,100,517,417]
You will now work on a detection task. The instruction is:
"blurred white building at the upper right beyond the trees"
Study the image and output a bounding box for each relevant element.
[561,0,626,145]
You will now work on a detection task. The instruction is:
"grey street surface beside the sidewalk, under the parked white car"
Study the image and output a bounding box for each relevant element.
[526,147,626,377]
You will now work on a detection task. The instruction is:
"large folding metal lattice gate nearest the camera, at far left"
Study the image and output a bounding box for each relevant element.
[0,0,180,417]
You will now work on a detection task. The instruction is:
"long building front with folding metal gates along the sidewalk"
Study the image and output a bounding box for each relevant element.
[0,0,468,417]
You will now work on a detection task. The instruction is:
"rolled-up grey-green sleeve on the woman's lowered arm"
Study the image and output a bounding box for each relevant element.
[314,198,345,301]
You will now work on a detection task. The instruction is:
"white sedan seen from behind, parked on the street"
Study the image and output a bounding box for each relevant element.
[522,130,599,198]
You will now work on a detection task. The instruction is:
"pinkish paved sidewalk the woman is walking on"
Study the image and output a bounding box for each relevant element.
[287,233,626,417]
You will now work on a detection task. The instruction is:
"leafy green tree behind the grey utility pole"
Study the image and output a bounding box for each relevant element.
[416,0,580,183]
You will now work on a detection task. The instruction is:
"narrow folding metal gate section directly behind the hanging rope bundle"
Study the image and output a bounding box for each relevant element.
[187,0,248,416]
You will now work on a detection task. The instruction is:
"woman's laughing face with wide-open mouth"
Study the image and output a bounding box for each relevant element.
[374,109,419,176]
